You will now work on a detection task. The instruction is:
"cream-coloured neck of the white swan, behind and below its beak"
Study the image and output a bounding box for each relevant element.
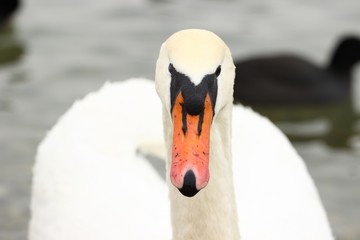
[164,104,240,240]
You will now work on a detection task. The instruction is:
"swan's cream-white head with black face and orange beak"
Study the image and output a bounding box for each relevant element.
[155,29,235,197]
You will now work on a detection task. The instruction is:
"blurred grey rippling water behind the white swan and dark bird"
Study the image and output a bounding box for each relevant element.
[0,0,360,240]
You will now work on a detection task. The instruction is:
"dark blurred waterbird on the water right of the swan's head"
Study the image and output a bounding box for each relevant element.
[234,36,360,105]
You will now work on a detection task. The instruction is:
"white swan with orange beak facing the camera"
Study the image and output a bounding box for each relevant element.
[29,29,333,240]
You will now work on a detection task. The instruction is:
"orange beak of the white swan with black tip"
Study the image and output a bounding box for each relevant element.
[170,92,213,197]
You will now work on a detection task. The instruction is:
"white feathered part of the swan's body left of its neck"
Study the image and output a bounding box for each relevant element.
[29,80,171,240]
